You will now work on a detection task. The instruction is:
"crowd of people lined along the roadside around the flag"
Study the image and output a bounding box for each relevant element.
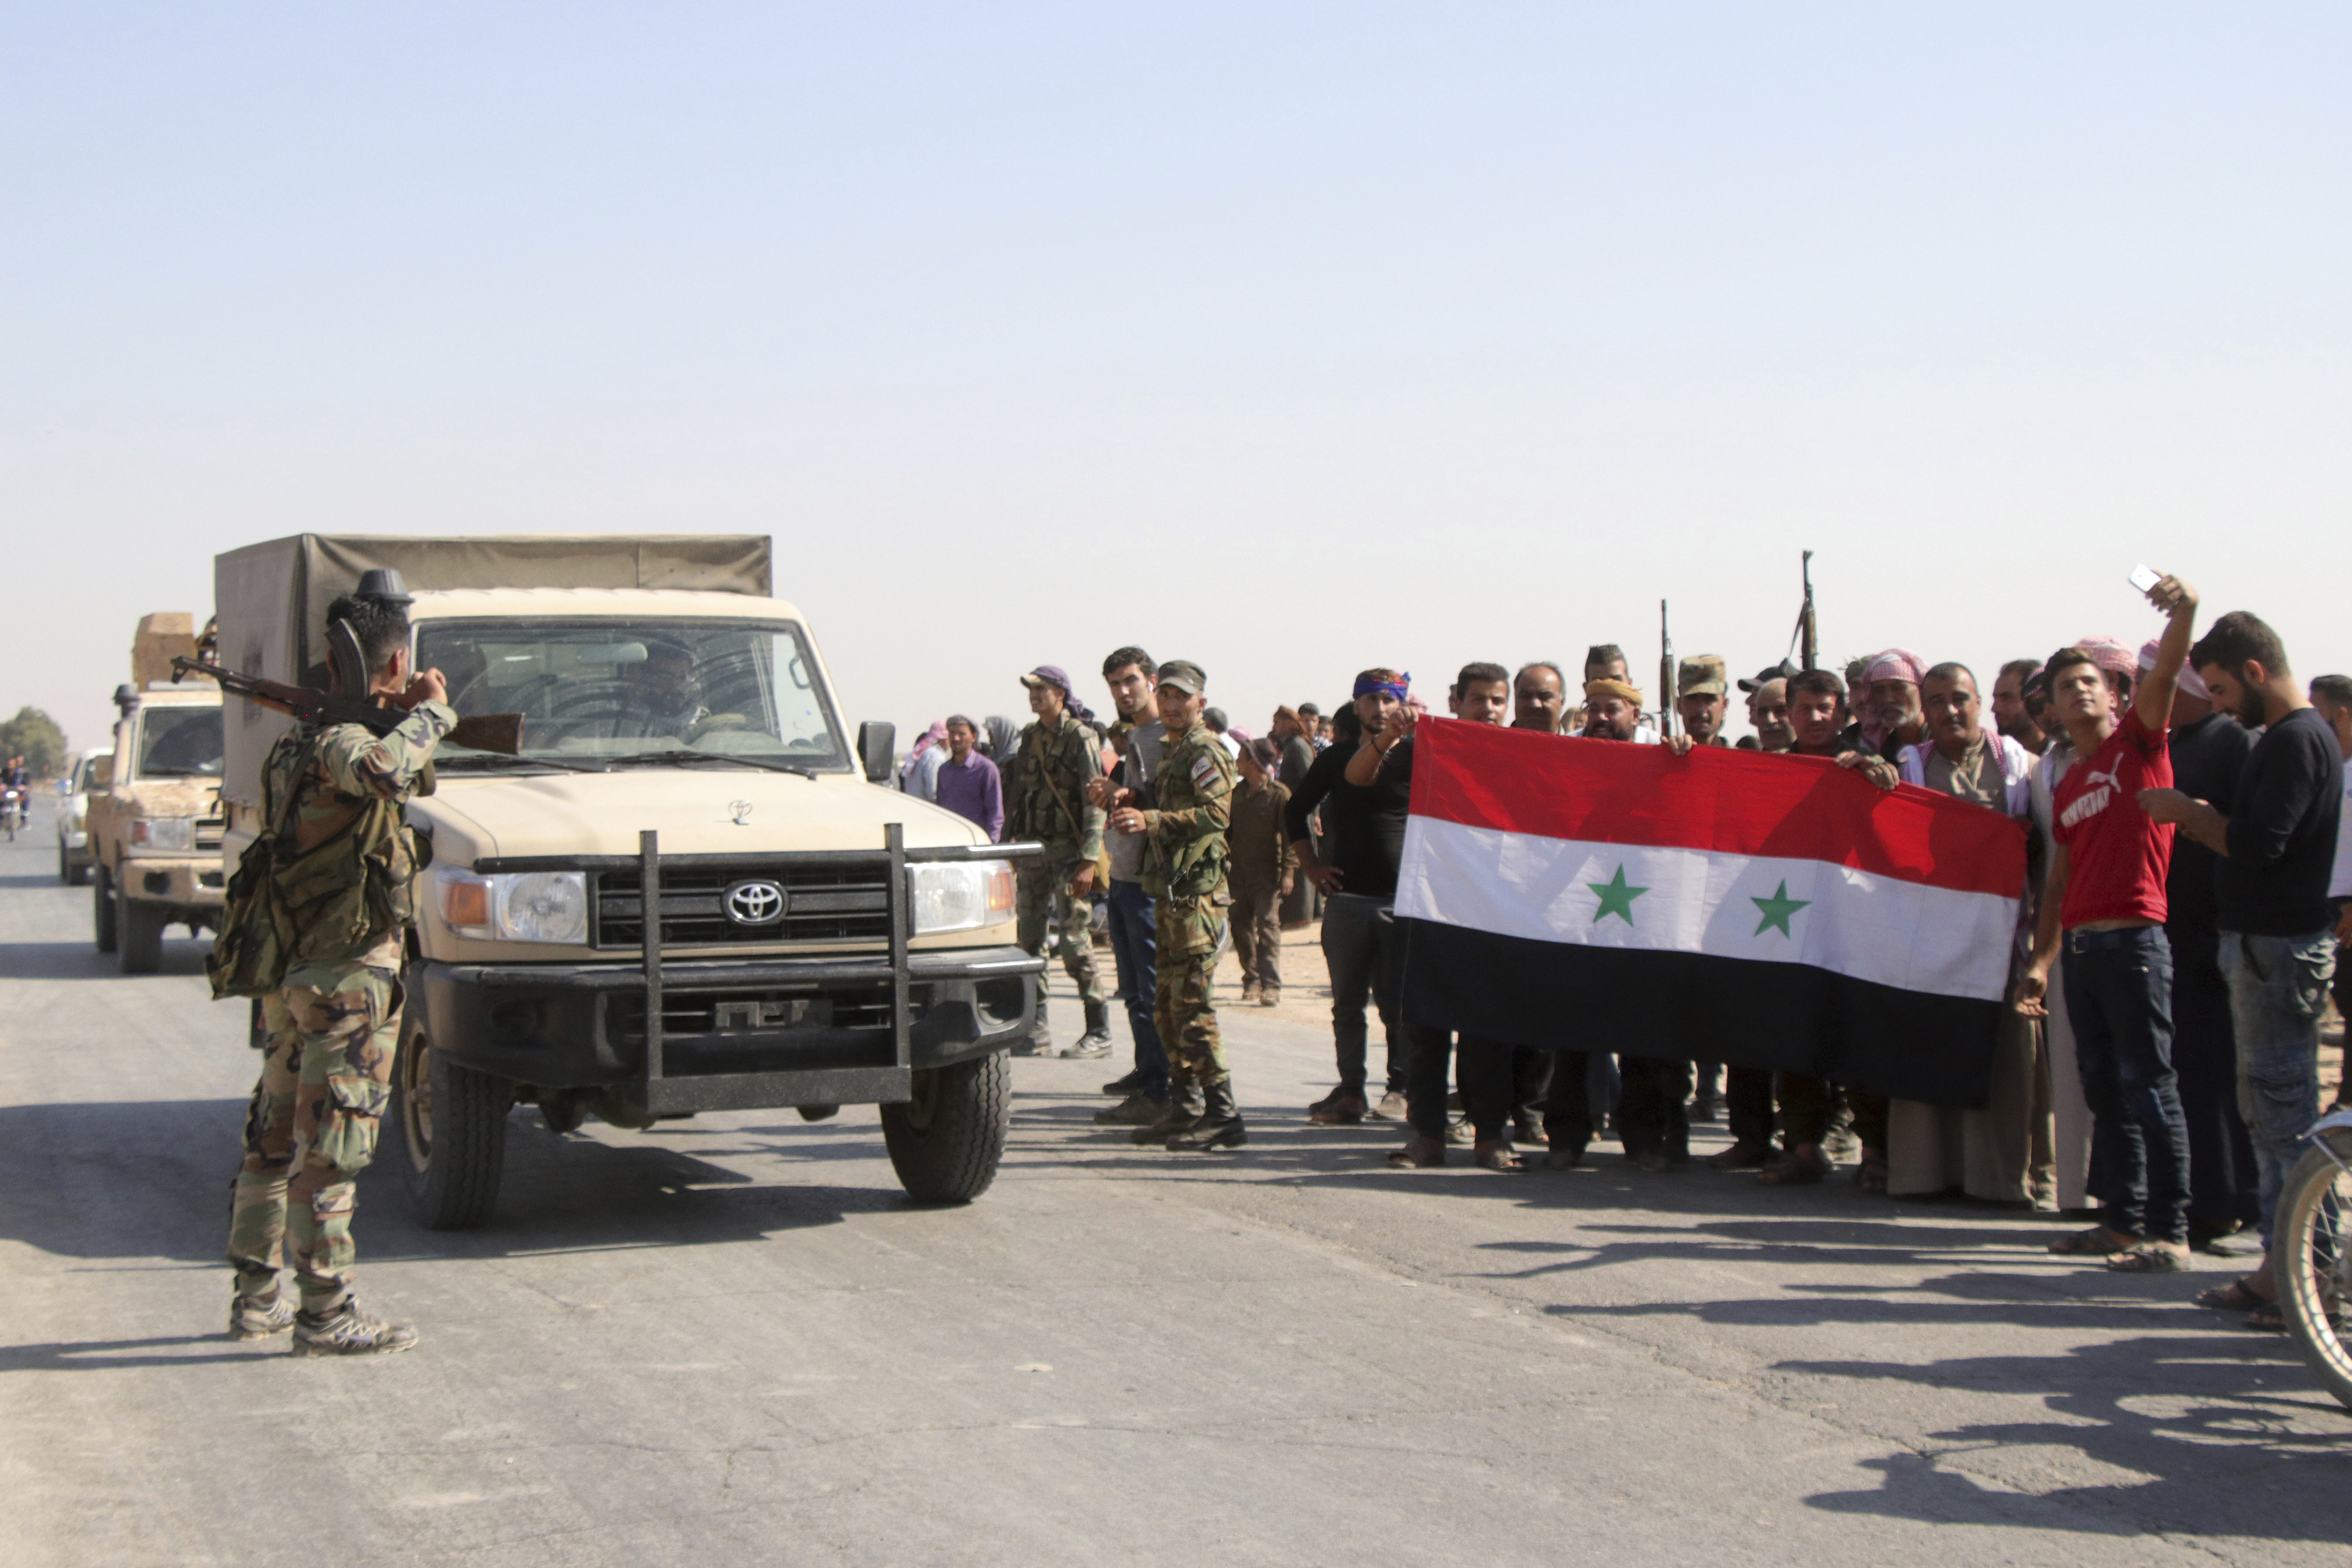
[901,595,2352,1326]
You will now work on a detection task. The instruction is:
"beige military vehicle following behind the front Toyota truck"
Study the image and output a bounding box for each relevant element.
[82,611,223,976]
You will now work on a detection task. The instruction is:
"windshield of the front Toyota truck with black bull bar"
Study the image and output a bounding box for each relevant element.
[416,618,849,769]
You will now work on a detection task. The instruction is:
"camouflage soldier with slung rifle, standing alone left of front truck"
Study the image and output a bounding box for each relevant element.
[228,574,456,1356]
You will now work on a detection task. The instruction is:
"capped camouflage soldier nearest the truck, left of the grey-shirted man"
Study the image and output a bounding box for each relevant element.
[1004,665,1110,1055]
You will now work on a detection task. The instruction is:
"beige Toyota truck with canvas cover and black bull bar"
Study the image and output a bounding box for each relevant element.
[216,534,1042,1230]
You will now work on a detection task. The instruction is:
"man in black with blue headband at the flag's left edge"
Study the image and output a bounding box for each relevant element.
[1284,670,1411,1126]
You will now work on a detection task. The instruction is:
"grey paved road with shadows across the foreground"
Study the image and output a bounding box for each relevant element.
[0,804,2352,1568]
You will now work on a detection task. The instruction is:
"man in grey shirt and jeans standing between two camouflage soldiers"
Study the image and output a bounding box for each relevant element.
[1094,646,1169,1126]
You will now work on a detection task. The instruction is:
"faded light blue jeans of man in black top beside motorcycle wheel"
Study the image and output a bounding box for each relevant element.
[2211,929,2335,1246]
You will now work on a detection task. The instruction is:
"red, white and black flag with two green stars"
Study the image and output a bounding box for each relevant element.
[1397,720,2025,1105]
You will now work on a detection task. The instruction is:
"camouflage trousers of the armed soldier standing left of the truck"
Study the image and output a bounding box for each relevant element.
[228,964,402,1312]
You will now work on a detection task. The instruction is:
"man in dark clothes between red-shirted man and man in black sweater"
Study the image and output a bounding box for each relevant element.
[2140,639,2256,1248]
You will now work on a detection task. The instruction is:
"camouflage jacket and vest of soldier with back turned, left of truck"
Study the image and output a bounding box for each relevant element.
[261,703,456,969]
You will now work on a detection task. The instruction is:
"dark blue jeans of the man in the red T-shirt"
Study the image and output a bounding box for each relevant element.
[2060,926,2190,1241]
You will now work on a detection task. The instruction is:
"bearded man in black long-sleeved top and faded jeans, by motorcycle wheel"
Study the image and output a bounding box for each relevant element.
[2140,609,2345,1321]
